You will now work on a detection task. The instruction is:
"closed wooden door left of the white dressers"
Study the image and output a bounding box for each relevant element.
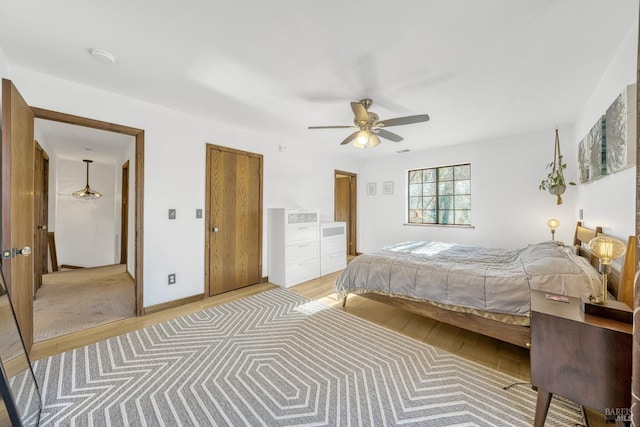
[205,145,262,296]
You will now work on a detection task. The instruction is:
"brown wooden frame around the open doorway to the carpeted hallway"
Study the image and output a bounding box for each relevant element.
[31,107,144,316]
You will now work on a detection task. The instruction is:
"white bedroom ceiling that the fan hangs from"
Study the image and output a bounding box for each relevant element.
[0,0,638,157]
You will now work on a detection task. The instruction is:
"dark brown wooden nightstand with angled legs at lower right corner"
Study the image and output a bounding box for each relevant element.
[530,291,633,427]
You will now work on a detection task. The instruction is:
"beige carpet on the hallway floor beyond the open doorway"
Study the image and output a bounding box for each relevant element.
[33,264,135,342]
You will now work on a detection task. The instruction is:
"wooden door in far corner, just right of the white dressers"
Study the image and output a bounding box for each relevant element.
[334,171,357,256]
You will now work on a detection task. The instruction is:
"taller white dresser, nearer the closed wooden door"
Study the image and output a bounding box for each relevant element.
[267,208,320,288]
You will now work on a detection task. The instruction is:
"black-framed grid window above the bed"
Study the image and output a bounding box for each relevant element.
[408,163,471,225]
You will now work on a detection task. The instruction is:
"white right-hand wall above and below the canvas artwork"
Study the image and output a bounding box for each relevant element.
[573,16,638,241]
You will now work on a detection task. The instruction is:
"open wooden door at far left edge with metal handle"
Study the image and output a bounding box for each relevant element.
[2,79,34,350]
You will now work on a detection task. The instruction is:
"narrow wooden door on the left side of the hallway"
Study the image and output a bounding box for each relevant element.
[33,142,49,297]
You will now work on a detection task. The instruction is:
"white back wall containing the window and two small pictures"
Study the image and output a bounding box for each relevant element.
[358,127,575,252]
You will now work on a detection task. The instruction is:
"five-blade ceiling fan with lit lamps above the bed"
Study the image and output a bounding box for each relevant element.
[309,98,429,148]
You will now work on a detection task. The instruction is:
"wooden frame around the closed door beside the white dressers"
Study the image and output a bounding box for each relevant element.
[204,144,264,298]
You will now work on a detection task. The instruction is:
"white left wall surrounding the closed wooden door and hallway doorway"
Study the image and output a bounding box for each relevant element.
[3,68,360,306]
